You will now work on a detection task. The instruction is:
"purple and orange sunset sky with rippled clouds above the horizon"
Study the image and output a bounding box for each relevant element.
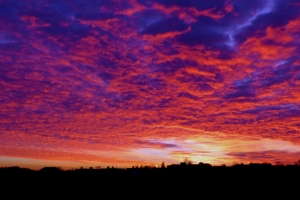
[0,0,300,169]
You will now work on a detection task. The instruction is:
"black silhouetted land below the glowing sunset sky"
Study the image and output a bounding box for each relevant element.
[0,164,300,199]
